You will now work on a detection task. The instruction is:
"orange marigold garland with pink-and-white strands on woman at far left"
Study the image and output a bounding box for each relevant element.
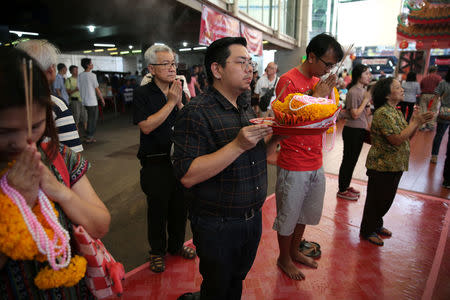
[0,163,87,289]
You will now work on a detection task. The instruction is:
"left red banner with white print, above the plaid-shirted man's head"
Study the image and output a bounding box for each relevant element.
[199,5,240,46]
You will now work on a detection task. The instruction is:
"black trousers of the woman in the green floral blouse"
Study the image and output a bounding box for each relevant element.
[360,170,403,237]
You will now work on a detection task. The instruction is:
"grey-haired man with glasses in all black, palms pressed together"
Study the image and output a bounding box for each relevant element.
[133,45,196,273]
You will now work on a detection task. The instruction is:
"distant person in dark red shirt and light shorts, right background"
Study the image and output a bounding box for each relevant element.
[419,66,442,130]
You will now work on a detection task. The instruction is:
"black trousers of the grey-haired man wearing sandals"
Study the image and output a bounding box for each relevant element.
[141,157,187,255]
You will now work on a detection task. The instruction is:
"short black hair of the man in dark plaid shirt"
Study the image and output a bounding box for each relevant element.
[205,37,247,85]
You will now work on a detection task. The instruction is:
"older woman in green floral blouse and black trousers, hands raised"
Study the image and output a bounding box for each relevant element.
[360,77,433,246]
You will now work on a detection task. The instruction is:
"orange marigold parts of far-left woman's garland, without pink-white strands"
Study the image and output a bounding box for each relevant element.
[0,164,87,289]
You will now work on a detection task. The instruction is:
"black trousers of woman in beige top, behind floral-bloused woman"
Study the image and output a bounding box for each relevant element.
[339,126,365,192]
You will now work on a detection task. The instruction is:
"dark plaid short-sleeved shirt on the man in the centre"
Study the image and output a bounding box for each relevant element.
[172,88,267,217]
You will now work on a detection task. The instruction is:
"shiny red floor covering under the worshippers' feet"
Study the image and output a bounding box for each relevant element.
[122,174,450,300]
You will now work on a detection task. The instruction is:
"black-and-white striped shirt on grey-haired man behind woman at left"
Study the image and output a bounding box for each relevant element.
[51,95,83,152]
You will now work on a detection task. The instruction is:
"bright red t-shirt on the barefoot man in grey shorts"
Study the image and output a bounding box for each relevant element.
[276,68,322,171]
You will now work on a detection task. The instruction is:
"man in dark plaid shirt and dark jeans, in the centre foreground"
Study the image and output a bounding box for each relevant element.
[172,38,280,300]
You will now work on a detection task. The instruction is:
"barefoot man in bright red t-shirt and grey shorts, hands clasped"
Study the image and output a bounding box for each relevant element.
[273,33,343,280]
